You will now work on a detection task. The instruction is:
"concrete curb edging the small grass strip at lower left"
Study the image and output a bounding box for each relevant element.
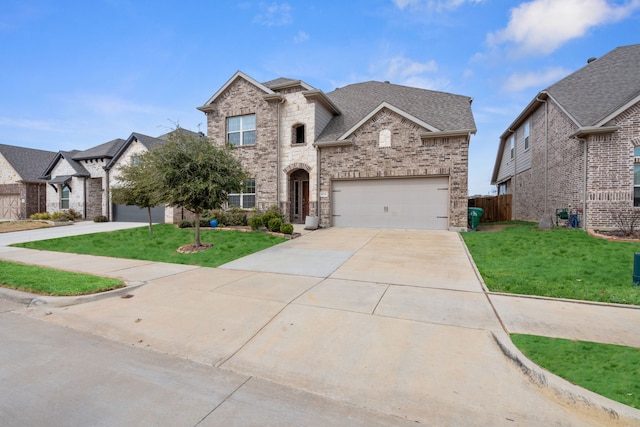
[0,282,146,307]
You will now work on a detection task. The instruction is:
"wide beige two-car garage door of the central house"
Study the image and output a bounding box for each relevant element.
[332,177,449,230]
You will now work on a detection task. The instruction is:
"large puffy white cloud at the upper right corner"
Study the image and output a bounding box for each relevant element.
[487,0,640,54]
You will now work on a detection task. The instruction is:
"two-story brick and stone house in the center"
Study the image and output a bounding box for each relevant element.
[198,72,476,230]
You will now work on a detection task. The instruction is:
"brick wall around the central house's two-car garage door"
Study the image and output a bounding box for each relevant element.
[320,109,469,228]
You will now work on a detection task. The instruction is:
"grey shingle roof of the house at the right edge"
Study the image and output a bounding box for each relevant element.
[546,44,640,127]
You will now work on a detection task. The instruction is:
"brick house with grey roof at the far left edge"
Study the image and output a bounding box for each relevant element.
[0,144,56,220]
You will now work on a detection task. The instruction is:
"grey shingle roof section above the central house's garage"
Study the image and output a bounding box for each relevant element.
[318,81,476,142]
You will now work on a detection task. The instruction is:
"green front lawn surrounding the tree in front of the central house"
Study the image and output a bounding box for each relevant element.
[15,224,285,267]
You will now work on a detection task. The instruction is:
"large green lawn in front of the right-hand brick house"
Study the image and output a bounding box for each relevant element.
[462,223,640,305]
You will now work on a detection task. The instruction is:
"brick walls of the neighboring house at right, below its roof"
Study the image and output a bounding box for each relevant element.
[508,99,640,230]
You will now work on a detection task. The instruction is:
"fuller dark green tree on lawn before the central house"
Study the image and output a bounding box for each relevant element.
[149,128,245,247]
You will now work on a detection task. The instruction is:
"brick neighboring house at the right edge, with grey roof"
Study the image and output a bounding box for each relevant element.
[491,44,640,230]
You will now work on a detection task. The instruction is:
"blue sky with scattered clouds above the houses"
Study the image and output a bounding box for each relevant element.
[0,0,640,194]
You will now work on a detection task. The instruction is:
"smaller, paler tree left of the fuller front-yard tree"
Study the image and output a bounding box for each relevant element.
[111,153,162,234]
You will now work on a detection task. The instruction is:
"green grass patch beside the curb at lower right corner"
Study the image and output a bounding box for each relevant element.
[511,334,640,409]
